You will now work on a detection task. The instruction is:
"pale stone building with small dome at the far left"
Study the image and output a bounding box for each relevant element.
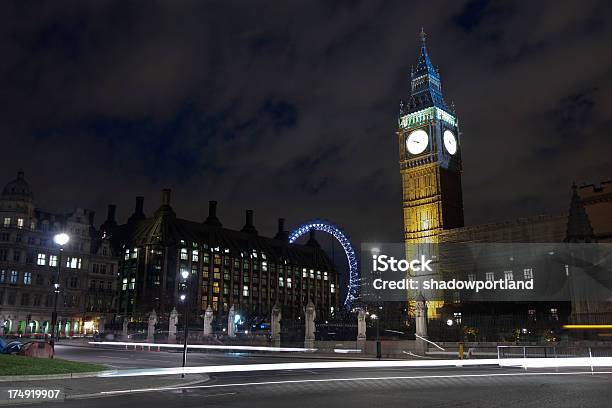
[0,171,117,335]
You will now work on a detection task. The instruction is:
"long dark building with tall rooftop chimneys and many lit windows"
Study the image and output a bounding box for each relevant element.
[109,190,340,321]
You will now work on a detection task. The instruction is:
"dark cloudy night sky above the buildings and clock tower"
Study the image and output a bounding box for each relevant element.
[0,0,612,249]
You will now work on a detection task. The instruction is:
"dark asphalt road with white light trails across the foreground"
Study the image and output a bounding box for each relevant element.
[35,347,612,408]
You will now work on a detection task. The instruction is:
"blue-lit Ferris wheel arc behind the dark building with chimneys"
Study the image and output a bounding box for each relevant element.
[289,220,359,309]
